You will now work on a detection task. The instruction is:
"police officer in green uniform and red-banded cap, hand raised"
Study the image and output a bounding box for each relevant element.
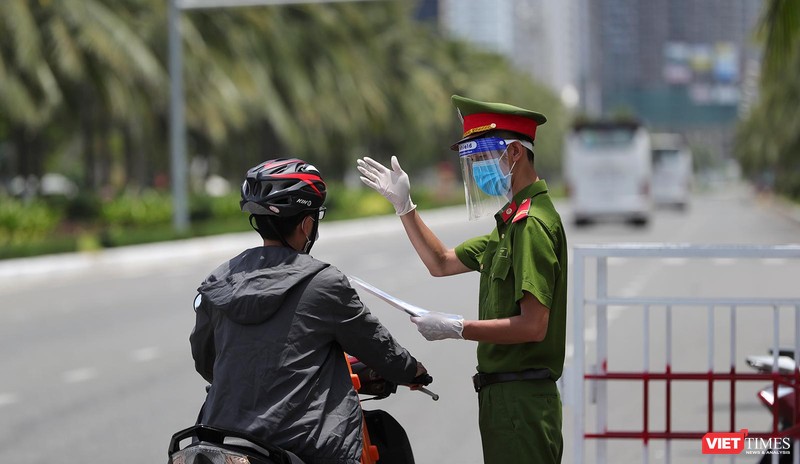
[358,95,567,464]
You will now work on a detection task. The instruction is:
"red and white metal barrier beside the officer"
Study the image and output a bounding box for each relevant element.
[571,244,800,463]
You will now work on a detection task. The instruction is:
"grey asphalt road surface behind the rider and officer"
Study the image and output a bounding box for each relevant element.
[0,183,800,464]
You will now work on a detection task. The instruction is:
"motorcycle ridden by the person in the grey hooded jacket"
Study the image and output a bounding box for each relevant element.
[167,356,439,464]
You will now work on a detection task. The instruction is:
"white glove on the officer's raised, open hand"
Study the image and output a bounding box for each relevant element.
[356,156,417,216]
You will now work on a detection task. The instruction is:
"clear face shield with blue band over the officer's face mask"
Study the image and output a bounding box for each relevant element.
[458,137,513,221]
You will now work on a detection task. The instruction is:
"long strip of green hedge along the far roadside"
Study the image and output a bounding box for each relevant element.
[0,183,463,259]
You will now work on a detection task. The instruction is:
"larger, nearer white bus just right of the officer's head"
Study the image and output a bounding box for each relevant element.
[564,121,652,226]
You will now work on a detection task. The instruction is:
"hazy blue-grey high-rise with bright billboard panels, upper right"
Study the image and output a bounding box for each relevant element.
[585,0,761,130]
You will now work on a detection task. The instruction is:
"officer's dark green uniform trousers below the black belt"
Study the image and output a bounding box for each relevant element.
[478,379,564,464]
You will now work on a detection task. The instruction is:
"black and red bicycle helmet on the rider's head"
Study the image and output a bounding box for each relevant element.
[239,158,326,217]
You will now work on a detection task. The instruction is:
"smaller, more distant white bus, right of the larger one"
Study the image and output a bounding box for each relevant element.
[650,134,692,209]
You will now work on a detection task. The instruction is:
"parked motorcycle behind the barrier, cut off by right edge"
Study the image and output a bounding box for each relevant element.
[746,350,800,464]
